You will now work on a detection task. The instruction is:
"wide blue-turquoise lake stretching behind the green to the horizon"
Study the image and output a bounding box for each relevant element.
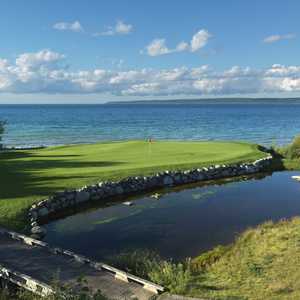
[0,100,300,146]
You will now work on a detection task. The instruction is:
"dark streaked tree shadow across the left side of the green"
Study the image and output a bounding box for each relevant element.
[0,151,124,201]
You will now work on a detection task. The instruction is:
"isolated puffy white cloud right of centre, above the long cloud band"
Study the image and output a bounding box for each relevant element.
[142,29,212,56]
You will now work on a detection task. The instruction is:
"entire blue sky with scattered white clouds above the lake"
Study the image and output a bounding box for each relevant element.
[0,0,300,104]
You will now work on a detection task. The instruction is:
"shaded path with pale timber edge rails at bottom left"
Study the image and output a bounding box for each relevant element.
[0,230,163,300]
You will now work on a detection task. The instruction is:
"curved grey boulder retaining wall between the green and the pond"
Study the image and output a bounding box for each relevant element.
[29,155,273,238]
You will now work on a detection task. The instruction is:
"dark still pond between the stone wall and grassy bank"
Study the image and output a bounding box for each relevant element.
[45,172,300,261]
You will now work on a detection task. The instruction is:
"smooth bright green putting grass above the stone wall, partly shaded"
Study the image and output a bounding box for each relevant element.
[0,141,265,229]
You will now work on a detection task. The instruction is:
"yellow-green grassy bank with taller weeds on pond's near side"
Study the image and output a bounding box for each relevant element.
[111,217,300,300]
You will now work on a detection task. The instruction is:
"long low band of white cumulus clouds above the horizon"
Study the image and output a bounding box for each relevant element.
[0,49,300,96]
